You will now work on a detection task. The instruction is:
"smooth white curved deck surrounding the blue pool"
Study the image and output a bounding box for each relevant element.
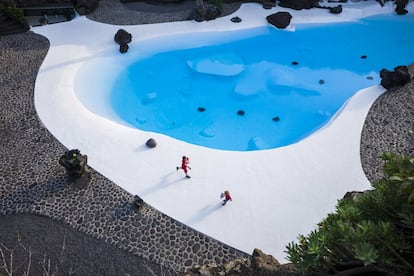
[33,1,414,262]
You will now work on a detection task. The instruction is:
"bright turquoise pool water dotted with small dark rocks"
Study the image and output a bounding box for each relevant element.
[111,15,414,151]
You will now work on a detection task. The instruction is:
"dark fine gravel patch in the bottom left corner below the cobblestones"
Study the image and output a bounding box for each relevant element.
[0,214,175,276]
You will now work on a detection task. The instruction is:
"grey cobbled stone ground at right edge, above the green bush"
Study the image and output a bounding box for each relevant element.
[361,80,414,182]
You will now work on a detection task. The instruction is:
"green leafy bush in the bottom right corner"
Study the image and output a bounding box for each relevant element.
[286,153,414,275]
